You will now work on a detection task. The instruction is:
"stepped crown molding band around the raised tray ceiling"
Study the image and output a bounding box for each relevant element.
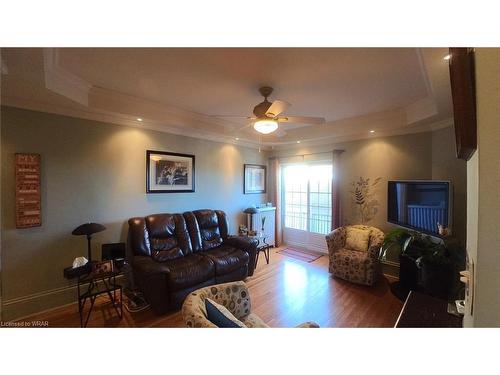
[2,48,449,150]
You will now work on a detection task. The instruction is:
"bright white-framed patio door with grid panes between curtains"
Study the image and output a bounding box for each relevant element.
[281,162,332,253]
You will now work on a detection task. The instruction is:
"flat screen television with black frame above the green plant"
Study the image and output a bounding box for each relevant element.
[387,180,452,235]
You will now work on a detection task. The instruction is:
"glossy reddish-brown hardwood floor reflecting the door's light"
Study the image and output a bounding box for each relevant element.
[26,249,403,327]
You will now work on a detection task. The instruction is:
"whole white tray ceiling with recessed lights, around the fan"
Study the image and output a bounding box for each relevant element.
[2,48,452,147]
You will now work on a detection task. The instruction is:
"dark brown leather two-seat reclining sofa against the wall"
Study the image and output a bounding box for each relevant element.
[128,210,257,314]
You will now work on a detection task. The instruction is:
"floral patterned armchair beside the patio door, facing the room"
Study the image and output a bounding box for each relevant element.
[326,225,385,285]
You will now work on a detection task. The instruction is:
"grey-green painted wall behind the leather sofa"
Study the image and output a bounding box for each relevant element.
[1,107,267,319]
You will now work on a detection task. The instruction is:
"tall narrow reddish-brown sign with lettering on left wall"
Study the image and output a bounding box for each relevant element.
[15,154,42,228]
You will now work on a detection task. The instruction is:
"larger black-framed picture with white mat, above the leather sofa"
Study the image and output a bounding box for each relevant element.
[146,150,195,194]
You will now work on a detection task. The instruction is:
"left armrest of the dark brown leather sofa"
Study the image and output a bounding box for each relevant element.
[131,255,170,314]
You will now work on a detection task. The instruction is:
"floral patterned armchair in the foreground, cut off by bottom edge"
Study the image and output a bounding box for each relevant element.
[182,281,319,328]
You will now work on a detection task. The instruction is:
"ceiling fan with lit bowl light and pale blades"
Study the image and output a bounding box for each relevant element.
[213,86,325,134]
